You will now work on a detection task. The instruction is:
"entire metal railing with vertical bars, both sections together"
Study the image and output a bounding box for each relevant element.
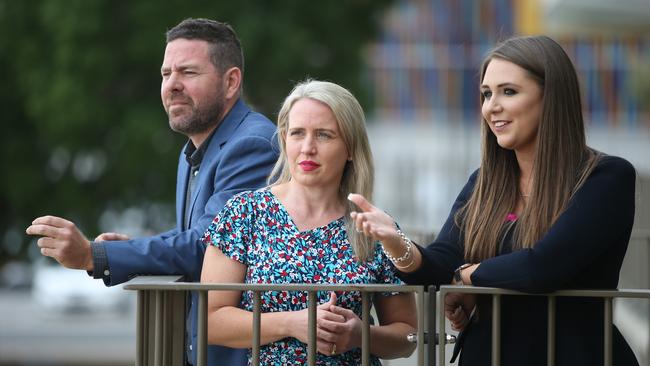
[124,276,650,366]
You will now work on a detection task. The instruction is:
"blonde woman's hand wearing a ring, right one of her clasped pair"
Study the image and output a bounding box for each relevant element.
[318,305,361,356]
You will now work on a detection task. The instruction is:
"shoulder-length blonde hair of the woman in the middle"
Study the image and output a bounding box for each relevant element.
[269,79,375,261]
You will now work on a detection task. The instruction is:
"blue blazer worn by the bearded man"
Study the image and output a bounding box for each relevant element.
[103,99,279,366]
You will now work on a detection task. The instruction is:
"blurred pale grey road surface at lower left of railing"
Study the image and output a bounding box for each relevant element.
[0,289,136,366]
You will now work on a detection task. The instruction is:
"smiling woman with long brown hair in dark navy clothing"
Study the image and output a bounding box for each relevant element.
[350,36,638,365]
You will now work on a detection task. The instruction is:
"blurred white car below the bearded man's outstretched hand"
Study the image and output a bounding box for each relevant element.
[32,260,133,314]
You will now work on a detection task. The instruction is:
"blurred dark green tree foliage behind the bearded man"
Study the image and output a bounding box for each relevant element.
[0,0,391,265]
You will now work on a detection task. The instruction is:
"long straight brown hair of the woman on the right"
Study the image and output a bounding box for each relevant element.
[455,36,599,263]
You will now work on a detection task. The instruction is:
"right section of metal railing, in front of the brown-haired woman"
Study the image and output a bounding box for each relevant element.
[437,286,650,366]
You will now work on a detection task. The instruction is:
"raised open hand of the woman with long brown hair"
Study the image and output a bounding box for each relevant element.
[348,193,401,243]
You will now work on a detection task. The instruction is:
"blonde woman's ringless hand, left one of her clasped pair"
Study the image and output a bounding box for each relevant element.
[289,292,345,355]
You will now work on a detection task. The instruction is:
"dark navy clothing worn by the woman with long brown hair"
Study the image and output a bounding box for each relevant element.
[398,156,638,365]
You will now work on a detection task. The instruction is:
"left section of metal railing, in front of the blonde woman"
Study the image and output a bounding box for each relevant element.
[124,276,435,366]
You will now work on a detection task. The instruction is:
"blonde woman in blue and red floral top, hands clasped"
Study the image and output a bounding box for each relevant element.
[201,81,416,365]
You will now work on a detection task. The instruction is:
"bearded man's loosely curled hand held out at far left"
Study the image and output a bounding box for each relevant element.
[25,216,93,271]
